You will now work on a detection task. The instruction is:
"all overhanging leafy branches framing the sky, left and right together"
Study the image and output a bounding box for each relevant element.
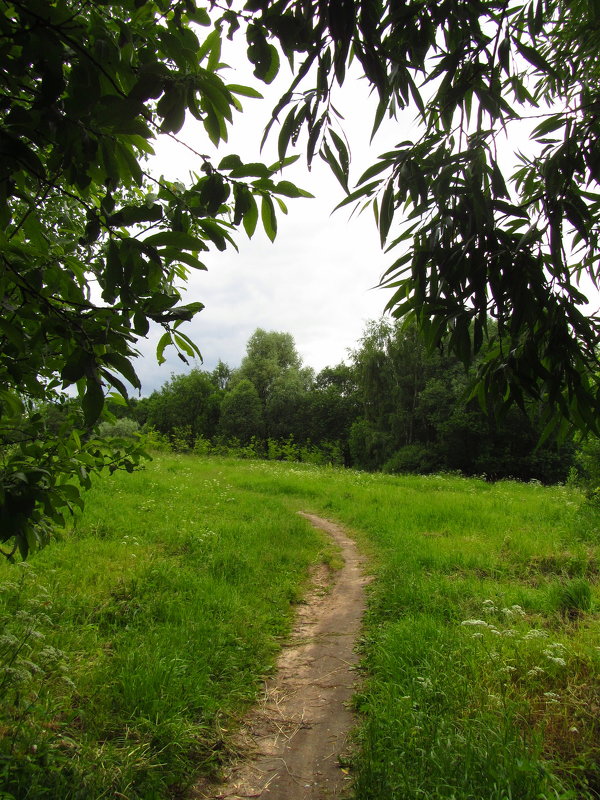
[0,0,600,555]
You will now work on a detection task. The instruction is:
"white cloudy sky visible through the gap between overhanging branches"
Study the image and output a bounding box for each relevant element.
[136,48,409,394]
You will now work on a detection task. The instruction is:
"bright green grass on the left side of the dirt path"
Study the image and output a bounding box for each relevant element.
[0,457,323,800]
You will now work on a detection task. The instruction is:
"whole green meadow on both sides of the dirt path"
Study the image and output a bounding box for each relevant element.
[0,455,600,800]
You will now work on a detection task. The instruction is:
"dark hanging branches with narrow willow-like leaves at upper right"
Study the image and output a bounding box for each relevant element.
[245,0,600,435]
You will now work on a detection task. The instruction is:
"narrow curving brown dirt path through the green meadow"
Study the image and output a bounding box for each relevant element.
[195,512,366,800]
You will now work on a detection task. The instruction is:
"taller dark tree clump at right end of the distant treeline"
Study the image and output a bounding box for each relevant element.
[349,320,573,483]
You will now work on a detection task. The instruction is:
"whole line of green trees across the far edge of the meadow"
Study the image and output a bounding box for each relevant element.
[98,320,593,483]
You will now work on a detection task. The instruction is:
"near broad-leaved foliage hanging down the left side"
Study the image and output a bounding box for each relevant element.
[0,0,306,557]
